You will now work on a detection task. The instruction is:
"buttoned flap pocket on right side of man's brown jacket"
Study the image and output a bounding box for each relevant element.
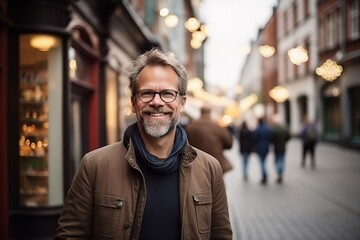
[193,191,212,233]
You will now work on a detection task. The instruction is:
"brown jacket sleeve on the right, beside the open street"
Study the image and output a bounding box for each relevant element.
[211,162,232,240]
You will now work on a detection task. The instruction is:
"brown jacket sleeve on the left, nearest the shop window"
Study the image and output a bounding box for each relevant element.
[54,156,94,239]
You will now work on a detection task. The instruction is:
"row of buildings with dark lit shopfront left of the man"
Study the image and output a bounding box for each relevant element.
[0,0,203,239]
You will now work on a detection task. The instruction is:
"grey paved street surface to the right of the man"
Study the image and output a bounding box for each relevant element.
[224,139,360,240]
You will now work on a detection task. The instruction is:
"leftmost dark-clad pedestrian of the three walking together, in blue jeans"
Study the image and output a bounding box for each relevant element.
[239,121,253,181]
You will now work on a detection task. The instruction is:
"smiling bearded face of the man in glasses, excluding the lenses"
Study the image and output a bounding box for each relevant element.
[132,66,186,138]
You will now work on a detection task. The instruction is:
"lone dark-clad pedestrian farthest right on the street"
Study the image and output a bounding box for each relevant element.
[300,116,318,168]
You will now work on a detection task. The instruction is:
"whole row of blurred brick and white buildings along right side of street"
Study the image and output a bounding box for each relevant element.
[239,0,360,148]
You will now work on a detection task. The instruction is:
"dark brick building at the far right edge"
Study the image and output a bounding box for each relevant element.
[316,0,360,148]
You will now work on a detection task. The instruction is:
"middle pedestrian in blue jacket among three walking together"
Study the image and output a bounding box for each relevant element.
[252,118,271,184]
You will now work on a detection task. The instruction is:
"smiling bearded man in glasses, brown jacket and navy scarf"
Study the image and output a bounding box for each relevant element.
[55,49,232,240]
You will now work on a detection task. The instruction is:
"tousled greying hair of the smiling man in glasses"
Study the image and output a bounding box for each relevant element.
[129,48,188,96]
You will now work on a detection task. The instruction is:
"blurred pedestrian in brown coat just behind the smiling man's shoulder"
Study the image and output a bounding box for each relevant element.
[186,104,233,173]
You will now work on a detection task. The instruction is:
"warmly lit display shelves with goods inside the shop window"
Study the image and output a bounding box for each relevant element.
[19,63,49,206]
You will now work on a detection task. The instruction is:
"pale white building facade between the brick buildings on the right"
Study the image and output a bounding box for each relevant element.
[277,0,319,134]
